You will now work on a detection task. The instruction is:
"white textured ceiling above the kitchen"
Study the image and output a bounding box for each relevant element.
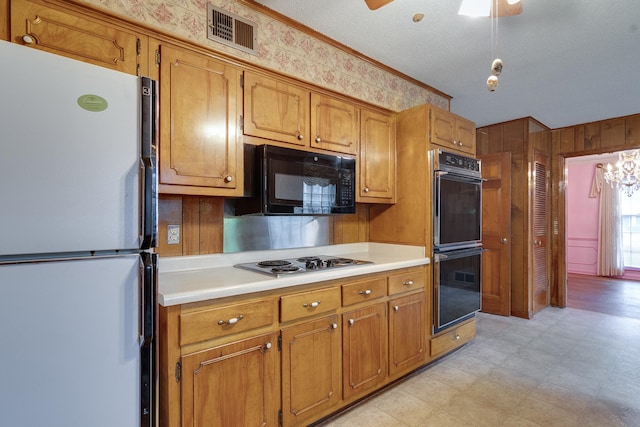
[256,0,640,128]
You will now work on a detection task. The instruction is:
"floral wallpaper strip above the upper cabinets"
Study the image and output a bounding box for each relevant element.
[81,0,449,111]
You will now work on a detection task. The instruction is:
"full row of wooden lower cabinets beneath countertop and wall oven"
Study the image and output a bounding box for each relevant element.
[159,266,475,427]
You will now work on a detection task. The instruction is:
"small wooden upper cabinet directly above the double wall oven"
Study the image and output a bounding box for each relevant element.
[429,107,476,155]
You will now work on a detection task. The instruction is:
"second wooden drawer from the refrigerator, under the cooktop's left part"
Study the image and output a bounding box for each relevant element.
[280,287,340,322]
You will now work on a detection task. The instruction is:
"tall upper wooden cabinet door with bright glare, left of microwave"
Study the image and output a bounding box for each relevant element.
[160,45,242,196]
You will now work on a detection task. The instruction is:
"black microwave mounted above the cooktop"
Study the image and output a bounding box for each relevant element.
[236,144,356,215]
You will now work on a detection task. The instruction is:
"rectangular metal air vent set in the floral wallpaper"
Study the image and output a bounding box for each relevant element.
[207,4,258,55]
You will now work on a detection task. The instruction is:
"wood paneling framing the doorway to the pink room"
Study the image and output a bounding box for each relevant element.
[551,114,640,307]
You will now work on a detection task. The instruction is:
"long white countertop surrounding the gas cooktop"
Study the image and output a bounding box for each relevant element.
[158,243,430,306]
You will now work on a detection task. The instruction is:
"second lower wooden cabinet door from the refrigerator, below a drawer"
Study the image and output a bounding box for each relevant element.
[282,315,342,426]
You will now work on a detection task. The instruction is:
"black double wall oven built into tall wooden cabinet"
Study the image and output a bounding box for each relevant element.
[430,149,483,333]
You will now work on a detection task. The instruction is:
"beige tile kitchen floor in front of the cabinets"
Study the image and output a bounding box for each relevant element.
[321,308,640,427]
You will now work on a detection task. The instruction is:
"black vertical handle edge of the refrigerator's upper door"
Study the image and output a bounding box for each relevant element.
[140,77,158,249]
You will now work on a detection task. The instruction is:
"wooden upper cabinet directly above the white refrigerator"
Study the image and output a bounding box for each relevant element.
[11,0,147,75]
